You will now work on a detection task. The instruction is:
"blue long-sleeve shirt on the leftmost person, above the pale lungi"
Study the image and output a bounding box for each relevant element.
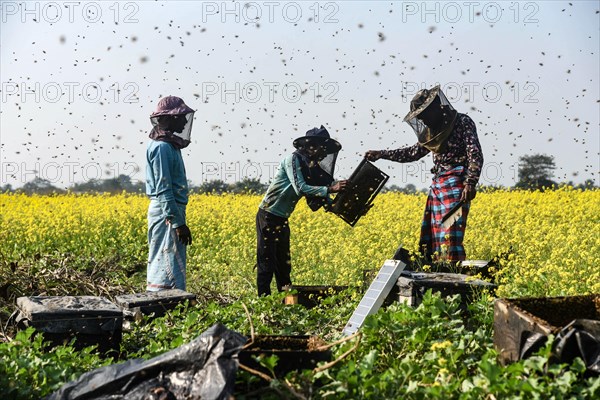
[146,140,188,228]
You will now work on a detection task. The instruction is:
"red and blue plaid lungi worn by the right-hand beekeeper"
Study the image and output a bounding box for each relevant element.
[419,166,470,261]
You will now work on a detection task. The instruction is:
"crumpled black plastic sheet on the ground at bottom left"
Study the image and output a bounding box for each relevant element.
[46,324,247,400]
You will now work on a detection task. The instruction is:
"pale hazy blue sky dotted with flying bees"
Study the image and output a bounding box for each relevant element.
[0,1,600,188]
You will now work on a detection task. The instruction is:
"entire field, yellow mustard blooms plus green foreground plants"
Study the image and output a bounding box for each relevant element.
[0,188,600,400]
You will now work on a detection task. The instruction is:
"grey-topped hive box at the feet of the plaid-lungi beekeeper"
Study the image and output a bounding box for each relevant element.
[390,271,496,307]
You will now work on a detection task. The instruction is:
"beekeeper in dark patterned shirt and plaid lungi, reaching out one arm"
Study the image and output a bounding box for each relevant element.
[365,85,483,261]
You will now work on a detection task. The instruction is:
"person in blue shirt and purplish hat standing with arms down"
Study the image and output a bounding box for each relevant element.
[146,96,194,291]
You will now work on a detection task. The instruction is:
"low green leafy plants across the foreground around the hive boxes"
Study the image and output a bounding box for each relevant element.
[0,289,600,399]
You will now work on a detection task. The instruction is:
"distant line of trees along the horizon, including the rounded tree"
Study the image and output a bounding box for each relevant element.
[0,154,598,194]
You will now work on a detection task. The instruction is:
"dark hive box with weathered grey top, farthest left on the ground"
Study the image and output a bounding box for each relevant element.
[16,296,123,353]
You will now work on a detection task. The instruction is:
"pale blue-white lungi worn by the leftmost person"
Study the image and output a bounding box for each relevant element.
[146,200,186,291]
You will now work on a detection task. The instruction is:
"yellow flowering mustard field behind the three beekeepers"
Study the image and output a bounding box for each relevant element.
[0,188,600,298]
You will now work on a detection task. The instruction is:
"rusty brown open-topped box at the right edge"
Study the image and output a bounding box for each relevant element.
[494,294,600,364]
